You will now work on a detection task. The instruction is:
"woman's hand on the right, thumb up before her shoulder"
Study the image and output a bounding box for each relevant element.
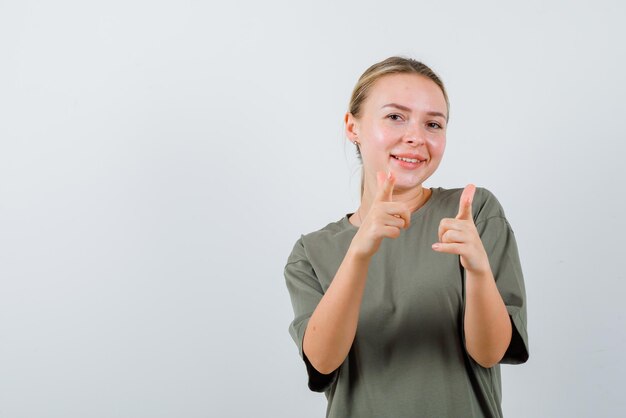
[433,184,491,274]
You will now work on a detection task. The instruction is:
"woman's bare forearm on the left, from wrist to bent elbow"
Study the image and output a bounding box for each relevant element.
[302,251,369,374]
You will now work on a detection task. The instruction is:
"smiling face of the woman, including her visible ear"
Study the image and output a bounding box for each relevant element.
[346,74,447,191]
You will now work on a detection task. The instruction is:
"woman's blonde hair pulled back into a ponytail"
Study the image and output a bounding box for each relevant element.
[348,57,450,197]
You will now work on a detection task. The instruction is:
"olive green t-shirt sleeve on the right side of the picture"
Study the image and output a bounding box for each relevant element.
[476,189,528,364]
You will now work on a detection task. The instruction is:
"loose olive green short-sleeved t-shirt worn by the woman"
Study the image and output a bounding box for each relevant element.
[285,187,528,418]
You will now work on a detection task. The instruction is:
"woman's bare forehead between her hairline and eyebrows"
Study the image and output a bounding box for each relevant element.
[365,74,447,114]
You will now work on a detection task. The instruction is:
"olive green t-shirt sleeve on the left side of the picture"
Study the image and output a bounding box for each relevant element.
[285,237,337,392]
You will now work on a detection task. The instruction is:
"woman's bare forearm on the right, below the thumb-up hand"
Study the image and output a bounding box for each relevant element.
[464,270,512,367]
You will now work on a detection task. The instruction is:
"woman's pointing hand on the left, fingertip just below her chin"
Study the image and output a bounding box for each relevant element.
[350,171,411,258]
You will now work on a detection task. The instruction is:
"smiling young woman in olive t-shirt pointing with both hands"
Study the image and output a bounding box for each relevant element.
[285,57,528,418]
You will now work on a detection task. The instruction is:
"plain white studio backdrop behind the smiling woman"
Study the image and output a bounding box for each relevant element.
[0,0,626,418]
